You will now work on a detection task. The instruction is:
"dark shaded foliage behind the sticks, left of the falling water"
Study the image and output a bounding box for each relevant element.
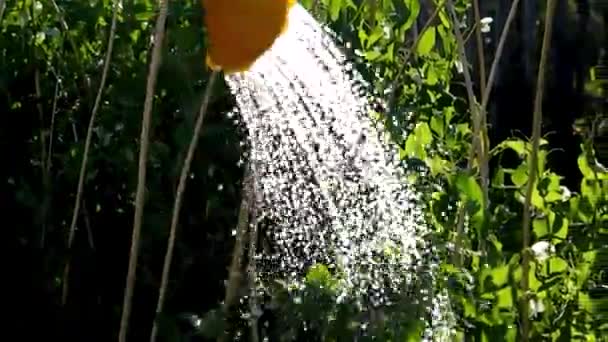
[0,0,246,341]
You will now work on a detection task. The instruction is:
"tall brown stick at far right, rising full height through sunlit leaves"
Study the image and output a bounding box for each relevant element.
[520,0,556,342]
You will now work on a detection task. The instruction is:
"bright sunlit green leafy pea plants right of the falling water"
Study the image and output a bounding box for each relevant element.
[280,0,608,341]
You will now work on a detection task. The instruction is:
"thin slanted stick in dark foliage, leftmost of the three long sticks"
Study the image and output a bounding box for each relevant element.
[61,0,120,305]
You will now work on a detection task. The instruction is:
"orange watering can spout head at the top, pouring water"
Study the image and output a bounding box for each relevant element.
[201,0,296,74]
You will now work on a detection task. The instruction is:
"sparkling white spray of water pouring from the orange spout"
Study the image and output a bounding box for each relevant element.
[227,5,452,340]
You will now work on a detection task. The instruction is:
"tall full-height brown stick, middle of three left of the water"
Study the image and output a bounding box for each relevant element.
[118,0,168,336]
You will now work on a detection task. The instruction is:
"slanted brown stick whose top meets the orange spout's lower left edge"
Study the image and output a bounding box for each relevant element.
[150,71,218,342]
